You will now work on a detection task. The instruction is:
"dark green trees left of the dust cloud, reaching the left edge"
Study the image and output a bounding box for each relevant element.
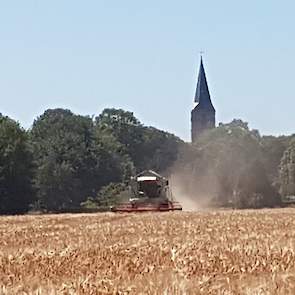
[0,109,182,214]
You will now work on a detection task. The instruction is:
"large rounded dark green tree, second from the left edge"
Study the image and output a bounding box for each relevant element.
[30,109,132,210]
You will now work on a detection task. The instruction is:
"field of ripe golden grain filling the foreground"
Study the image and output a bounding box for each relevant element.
[0,209,295,294]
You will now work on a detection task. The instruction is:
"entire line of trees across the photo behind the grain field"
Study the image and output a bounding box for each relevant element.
[0,109,295,214]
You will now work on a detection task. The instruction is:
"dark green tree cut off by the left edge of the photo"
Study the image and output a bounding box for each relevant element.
[0,114,34,214]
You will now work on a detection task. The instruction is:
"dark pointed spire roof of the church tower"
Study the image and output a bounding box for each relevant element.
[195,56,214,109]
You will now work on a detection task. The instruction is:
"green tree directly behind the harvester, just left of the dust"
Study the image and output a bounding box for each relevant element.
[96,109,182,172]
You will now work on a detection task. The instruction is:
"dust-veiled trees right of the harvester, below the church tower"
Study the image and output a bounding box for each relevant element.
[176,119,295,208]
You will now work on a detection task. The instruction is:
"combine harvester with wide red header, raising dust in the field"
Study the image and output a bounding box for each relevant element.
[111,170,182,212]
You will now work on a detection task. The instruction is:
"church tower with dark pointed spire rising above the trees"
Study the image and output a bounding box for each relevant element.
[191,57,215,143]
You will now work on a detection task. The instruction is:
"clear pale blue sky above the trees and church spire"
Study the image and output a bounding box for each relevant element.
[0,0,295,140]
